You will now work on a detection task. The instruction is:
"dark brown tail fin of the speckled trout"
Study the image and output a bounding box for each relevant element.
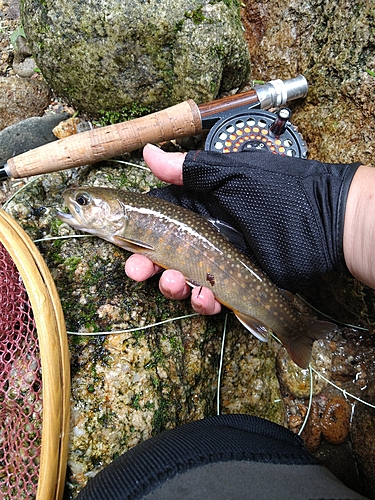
[280,320,336,368]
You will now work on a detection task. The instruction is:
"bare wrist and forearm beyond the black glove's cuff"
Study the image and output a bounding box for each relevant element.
[343,165,375,289]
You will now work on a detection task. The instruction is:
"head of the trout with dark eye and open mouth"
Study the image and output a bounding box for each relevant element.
[56,187,126,239]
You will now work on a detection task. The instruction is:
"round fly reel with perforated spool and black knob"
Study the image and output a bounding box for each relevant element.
[205,108,307,158]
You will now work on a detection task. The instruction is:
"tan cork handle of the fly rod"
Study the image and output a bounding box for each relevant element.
[6,100,202,178]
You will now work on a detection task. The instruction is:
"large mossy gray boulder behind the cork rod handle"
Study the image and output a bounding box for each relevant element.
[21,0,249,113]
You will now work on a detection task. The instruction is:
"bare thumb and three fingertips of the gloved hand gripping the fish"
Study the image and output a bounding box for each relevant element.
[125,144,221,314]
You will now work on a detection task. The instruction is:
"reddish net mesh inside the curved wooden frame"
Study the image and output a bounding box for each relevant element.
[0,243,42,500]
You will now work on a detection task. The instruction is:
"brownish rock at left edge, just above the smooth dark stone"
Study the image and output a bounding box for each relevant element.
[0,77,51,130]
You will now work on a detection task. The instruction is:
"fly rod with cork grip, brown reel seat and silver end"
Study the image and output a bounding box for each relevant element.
[0,75,308,180]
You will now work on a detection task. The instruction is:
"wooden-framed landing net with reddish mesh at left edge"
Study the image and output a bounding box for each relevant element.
[0,210,70,500]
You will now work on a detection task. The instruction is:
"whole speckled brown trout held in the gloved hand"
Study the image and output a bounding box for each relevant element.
[57,187,335,368]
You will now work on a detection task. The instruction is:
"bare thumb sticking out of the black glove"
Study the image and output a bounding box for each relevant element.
[143,144,186,186]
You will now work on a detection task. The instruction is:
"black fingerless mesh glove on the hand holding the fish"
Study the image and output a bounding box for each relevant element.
[150,150,360,292]
